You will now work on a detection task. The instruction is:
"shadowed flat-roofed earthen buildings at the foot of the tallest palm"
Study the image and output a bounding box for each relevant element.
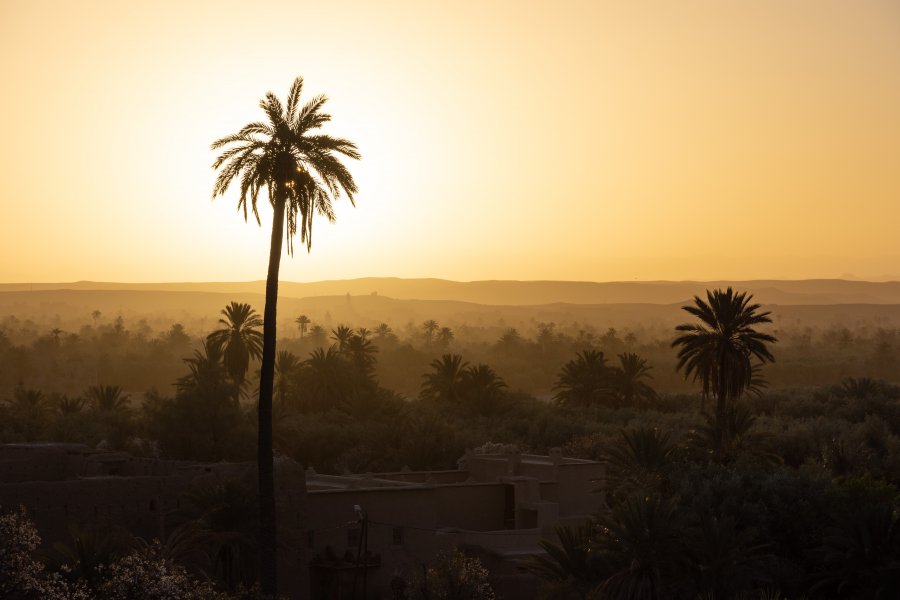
[0,444,604,600]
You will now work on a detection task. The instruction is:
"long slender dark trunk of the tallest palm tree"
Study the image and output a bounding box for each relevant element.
[256,193,285,597]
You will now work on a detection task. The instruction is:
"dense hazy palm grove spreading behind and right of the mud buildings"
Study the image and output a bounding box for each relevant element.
[0,290,900,598]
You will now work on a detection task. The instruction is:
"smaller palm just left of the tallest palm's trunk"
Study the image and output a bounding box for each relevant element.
[206,302,263,389]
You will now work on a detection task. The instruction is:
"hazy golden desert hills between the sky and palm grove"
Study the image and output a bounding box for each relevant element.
[0,278,900,335]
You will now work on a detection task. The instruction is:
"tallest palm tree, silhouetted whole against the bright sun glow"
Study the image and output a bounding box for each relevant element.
[212,77,360,595]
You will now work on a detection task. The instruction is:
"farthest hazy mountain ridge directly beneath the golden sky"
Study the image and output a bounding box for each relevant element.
[0,277,900,306]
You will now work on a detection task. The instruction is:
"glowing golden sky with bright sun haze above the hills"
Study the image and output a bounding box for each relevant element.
[0,0,900,282]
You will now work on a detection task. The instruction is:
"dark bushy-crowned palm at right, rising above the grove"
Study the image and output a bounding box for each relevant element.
[672,287,776,452]
